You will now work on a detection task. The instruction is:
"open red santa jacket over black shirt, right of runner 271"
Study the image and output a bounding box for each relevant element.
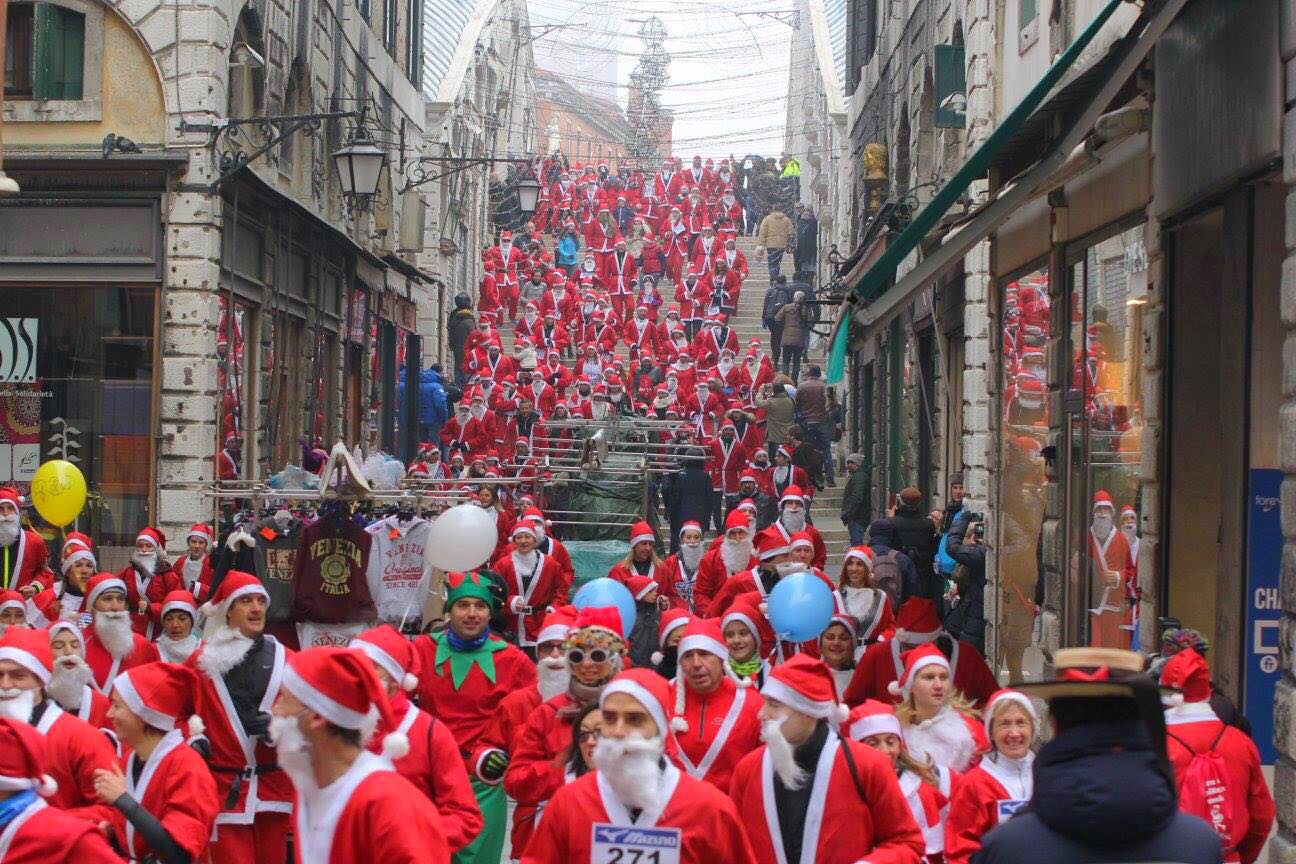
[730,730,924,864]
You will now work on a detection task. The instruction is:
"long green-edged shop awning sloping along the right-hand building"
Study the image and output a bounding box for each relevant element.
[828,0,1188,383]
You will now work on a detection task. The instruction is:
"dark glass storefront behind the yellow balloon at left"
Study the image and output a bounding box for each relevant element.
[0,286,157,546]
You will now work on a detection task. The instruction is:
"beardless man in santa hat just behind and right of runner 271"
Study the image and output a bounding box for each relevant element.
[670,618,762,791]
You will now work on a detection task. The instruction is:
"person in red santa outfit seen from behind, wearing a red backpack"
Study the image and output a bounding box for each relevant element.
[1161,649,1275,864]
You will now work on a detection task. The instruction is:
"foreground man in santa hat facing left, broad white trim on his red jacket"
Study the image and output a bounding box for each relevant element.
[266,648,450,864]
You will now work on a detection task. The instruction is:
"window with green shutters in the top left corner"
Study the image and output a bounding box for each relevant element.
[4,3,86,101]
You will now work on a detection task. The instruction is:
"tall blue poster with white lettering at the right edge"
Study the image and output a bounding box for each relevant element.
[1243,468,1283,766]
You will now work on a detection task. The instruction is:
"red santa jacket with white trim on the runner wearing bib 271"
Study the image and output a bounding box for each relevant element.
[522,763,754,864]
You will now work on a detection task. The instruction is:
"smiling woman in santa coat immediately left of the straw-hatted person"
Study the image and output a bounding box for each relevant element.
[945,690,1039,864]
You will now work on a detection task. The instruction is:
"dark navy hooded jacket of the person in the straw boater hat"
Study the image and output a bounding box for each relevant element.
[972,723,1221,864]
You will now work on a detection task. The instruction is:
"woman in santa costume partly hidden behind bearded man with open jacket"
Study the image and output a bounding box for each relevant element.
[841,699,959,864]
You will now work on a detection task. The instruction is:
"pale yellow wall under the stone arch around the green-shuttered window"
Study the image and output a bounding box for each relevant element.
[4,10,166,149]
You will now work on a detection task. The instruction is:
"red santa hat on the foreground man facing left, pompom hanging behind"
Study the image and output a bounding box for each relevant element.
[284,648,410,759]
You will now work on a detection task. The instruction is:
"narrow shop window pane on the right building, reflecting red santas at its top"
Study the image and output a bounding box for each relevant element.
[994,268,1051,681]
